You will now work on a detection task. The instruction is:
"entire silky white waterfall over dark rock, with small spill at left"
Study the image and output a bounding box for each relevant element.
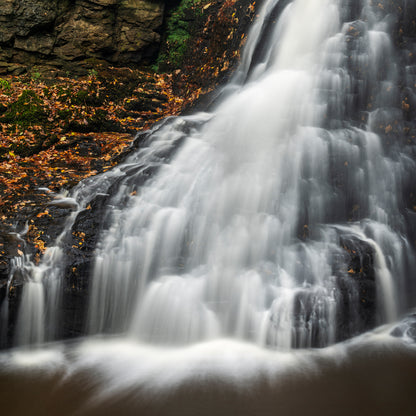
[0,0,416,349]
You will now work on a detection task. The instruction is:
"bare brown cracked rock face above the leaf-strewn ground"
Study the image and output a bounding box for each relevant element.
[0,0,164,73]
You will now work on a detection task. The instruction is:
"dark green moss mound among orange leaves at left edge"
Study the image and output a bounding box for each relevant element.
[0,90,47,128]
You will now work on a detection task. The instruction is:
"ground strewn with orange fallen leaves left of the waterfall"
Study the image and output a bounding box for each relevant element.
[0,68,208,252]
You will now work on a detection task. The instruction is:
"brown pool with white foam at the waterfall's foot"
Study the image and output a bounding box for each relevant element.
[0,320,416,416]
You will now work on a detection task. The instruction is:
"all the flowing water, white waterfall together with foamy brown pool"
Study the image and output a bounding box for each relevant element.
[0,0,416,416]
